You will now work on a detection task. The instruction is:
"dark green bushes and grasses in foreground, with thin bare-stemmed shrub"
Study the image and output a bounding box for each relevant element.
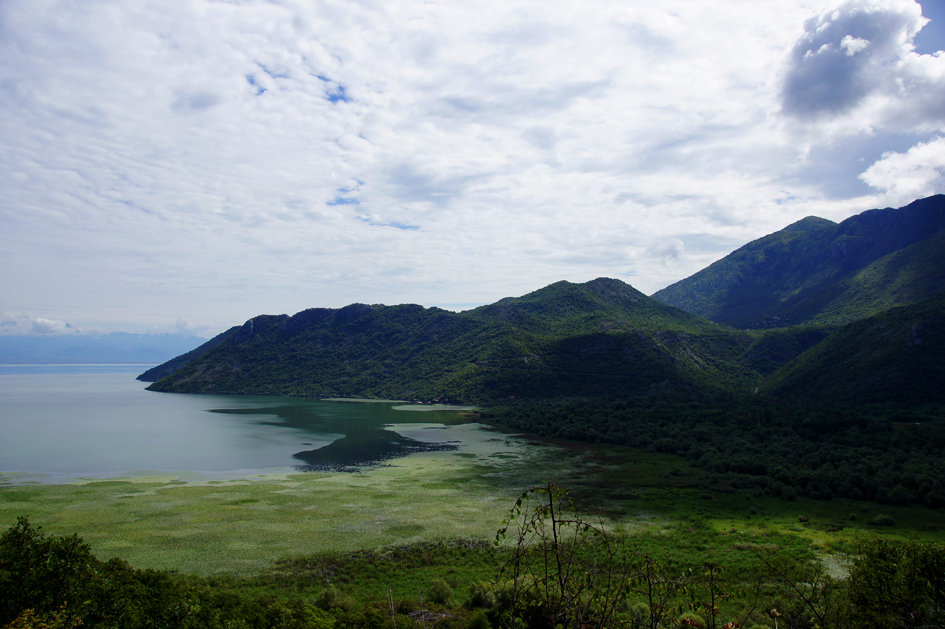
[0,484,945,629]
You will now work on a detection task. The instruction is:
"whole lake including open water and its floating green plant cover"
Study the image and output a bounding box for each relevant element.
[0,365,568,574]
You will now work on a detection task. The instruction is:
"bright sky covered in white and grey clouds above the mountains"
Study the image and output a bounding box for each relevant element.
[0,0,945,336]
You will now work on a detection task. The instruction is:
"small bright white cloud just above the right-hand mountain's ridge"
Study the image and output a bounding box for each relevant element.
[860,137,945,205]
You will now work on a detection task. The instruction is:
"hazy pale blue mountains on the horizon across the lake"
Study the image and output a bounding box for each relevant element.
[0,332,204,364]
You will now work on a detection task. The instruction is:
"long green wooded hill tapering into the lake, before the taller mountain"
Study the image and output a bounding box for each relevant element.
[142,278,772,402]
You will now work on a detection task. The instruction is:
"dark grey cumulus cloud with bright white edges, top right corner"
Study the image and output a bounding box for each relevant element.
[780,0,945,132]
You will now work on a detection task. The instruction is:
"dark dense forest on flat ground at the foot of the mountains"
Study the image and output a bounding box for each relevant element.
[482,396,945,509]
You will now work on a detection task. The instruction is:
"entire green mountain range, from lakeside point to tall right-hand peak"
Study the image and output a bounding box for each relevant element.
[139,195,945,406]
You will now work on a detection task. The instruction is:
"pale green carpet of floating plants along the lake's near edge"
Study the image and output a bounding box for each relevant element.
[0,424,549,574]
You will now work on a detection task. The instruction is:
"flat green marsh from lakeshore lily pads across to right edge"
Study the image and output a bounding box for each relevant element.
[0,424,945,575]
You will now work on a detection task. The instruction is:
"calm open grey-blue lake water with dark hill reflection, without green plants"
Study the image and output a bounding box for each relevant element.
[0,365,470,480]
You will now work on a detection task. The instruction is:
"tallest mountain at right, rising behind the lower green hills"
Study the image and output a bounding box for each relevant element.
[653,195,945,328]
